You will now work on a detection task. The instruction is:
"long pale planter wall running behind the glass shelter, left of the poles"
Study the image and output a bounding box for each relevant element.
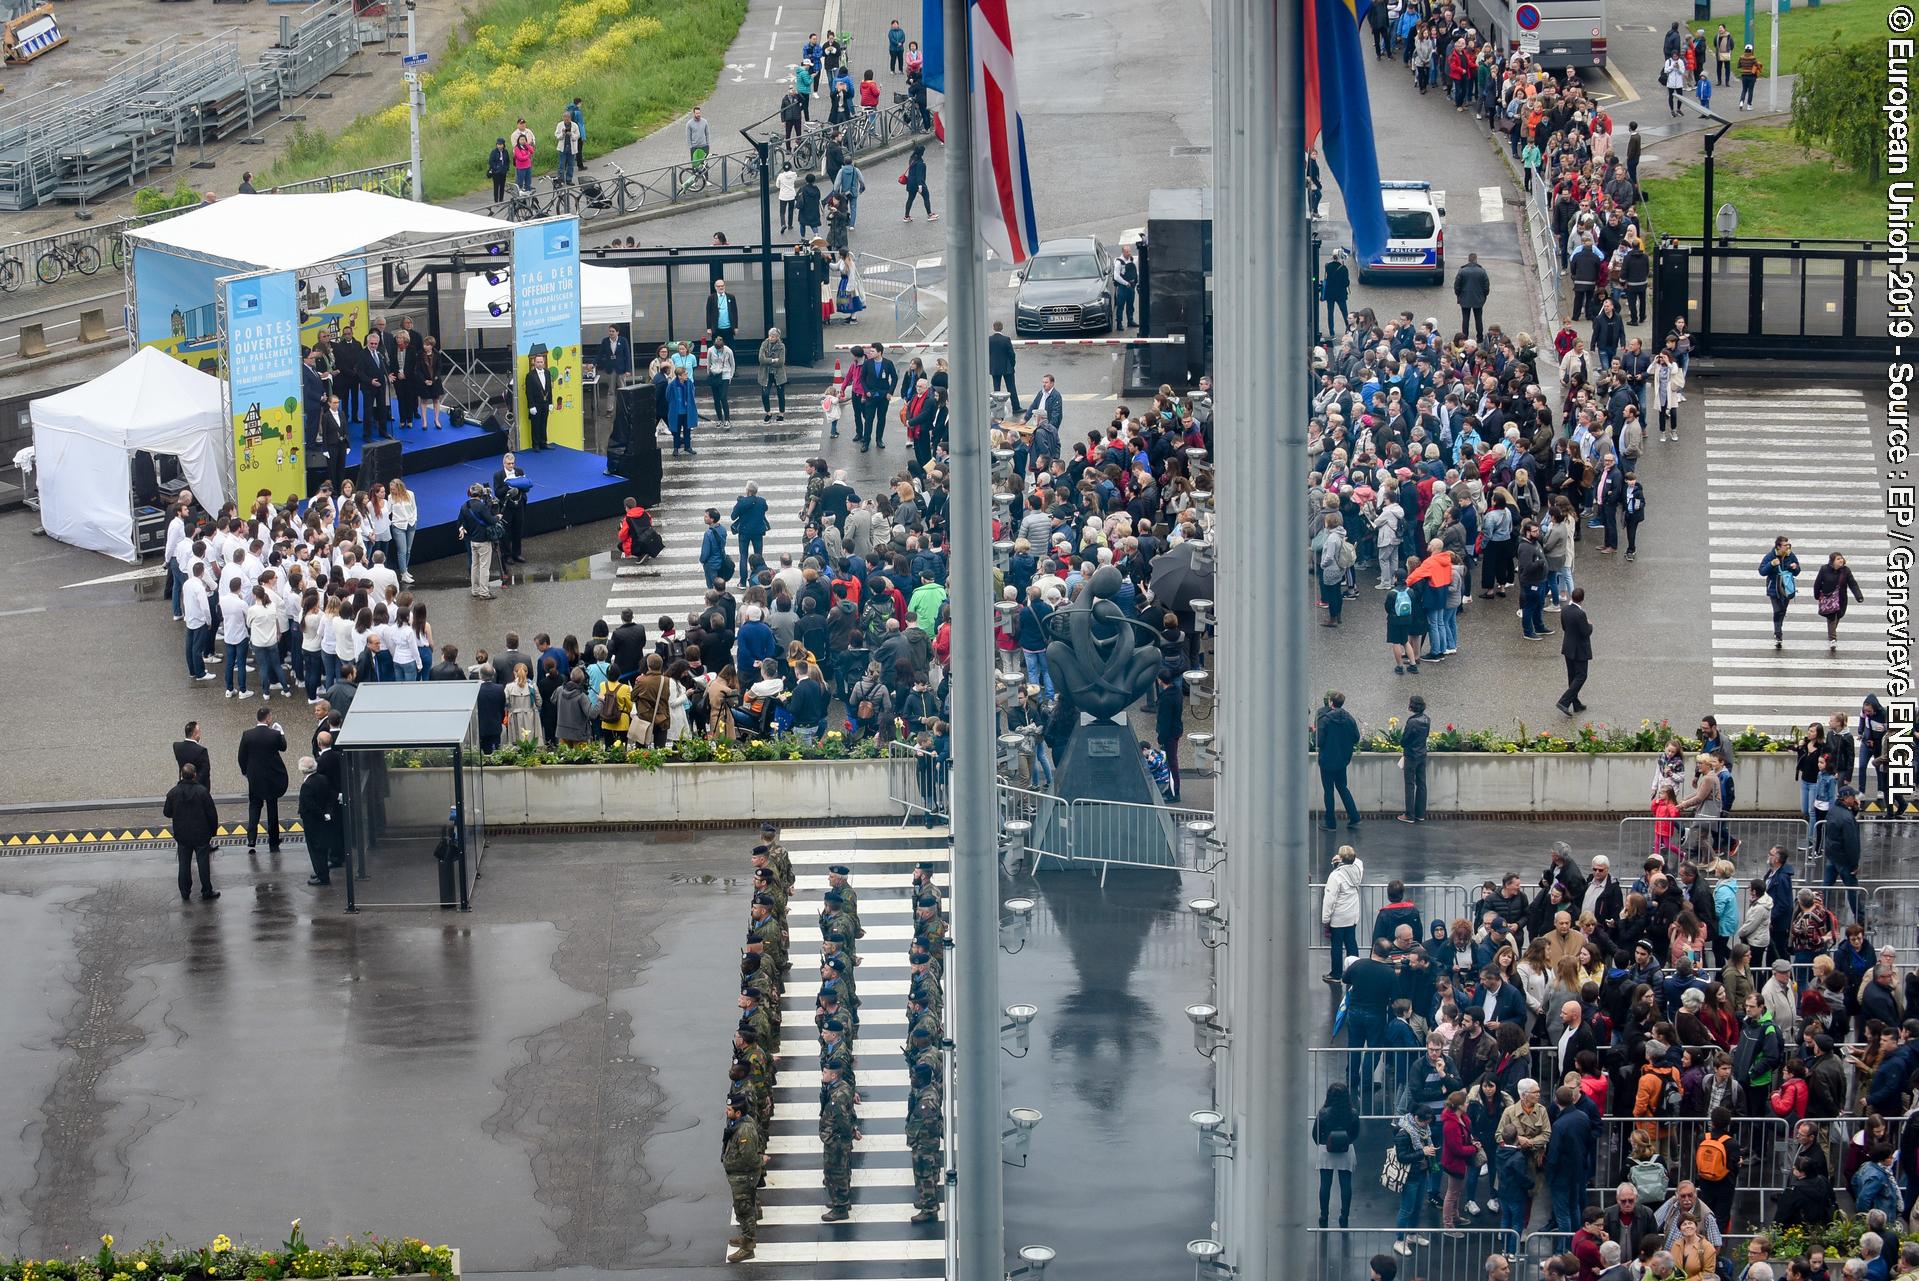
[388,759,900,825]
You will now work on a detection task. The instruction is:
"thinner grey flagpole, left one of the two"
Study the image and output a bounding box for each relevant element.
[942,0,1006,1281]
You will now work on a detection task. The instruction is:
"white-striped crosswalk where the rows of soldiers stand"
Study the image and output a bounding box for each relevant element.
[740,824,948,1281]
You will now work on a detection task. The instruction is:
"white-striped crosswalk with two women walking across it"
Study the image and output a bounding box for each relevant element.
[1704,387,1886,733]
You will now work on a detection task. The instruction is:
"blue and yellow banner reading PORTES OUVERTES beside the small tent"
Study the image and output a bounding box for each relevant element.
[225,272,307,506]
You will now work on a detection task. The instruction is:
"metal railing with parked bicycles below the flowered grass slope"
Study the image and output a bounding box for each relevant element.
[486,104,931,222]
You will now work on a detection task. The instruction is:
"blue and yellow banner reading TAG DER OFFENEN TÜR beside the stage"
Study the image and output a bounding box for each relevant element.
[512,219,587,449]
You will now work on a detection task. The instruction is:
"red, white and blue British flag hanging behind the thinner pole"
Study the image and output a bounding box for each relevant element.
[921,0,1040,265]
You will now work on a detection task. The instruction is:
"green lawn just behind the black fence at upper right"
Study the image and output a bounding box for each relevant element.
[1643,127,1886,240]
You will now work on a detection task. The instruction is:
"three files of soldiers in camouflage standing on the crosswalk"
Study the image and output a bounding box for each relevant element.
[720,823,948,1264]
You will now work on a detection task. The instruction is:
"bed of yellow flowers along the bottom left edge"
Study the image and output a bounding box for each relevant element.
[0,1220,461,1281]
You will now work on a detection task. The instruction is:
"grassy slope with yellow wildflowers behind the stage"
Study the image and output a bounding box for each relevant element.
[265,0,746,199]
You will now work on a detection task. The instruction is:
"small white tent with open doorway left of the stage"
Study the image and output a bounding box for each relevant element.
[27,347,232,564]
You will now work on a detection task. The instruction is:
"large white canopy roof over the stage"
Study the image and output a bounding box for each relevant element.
[129,192,512,270]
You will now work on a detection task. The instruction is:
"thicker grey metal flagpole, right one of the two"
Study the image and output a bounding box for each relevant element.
[1213,0,1304,1281]
